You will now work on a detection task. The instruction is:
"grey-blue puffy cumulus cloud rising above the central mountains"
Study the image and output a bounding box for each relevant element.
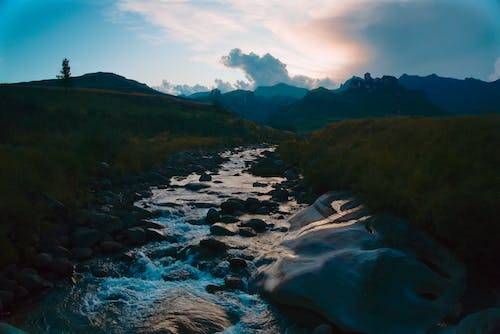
[221,49,335,88]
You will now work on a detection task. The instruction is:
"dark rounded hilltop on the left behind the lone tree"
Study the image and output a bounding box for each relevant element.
[12,72,164,95]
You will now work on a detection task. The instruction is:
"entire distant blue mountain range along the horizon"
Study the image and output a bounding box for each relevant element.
[189,73,500,132]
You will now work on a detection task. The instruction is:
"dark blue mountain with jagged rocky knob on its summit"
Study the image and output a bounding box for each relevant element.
[270,74,442,132]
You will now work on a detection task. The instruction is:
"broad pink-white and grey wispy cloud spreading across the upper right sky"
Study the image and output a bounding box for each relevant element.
[117,0,500,81]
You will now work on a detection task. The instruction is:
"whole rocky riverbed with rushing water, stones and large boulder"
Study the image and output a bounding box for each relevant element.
[0,147,500,334]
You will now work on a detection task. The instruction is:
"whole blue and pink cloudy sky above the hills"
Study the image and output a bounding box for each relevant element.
[0,0,500,94]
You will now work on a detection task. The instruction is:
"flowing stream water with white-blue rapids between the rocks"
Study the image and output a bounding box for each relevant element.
[13,149,302,333]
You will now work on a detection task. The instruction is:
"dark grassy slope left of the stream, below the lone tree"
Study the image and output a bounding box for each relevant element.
[0,85,284,264]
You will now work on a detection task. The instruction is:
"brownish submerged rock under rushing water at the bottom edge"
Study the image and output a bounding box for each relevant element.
[139,291,232,334]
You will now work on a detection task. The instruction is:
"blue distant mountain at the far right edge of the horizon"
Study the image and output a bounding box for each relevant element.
[399,74,500,114]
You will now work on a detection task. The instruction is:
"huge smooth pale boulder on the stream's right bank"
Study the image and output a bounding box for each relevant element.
[257,192,465,334]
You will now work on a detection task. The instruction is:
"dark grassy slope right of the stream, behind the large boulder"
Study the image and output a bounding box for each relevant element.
[281,115,500,271]
